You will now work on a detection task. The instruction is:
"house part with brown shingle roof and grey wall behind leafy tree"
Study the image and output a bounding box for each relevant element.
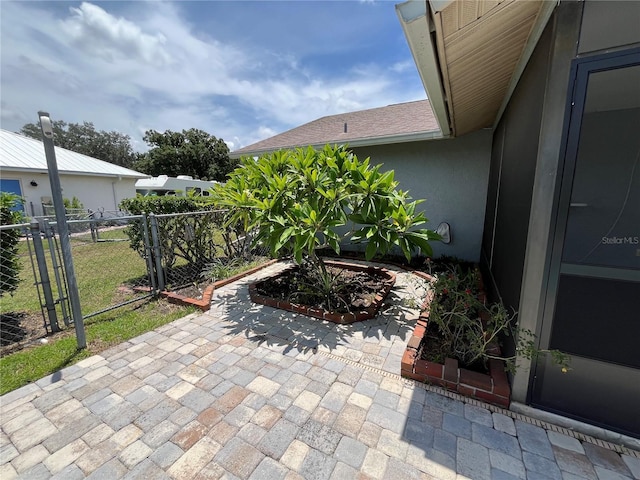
[230,100,491,261]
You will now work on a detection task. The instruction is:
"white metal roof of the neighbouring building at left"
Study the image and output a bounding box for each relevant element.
[0,130,149,178]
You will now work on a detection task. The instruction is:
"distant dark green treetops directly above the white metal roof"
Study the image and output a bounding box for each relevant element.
[20,120,137,168]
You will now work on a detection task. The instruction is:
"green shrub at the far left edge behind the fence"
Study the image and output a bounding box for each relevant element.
[0,192,23,296]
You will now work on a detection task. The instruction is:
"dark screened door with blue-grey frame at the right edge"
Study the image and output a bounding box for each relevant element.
[532,51,640,436]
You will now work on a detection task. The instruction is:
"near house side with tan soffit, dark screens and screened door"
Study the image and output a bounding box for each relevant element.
[397,0,640,438]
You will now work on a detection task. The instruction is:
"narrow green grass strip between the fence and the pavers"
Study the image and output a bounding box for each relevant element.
[0,300,195,395]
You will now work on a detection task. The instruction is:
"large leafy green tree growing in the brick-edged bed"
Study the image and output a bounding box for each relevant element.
[210,145,439,296]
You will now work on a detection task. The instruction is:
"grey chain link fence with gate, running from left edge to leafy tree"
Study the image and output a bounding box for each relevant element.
[0,210,266,353]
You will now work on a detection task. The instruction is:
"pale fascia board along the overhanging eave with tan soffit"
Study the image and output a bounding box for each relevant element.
[396,0,451,137]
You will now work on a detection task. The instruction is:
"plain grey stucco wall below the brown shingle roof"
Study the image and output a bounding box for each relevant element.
[353,131,491,261]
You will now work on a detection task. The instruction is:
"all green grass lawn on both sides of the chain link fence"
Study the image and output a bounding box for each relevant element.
[0,232,264,395]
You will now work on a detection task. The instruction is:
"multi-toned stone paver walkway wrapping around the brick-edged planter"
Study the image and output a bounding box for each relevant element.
[0,264,640,480]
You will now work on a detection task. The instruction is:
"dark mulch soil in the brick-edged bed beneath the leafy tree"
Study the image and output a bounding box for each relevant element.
[256,266,385,313]
